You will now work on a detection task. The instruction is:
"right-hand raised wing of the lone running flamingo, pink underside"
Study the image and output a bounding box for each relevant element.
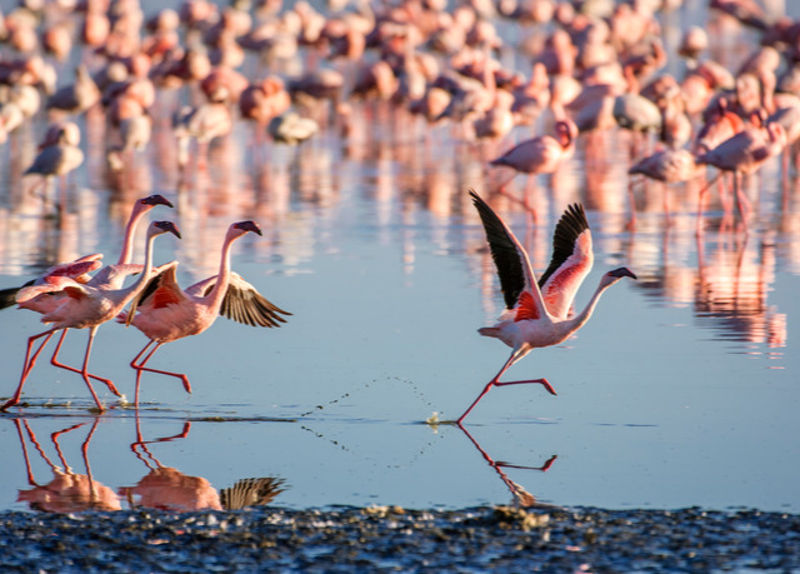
[539,203,594,319]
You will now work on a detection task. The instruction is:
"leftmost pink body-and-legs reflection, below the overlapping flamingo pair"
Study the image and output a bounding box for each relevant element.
[14,418,121,513]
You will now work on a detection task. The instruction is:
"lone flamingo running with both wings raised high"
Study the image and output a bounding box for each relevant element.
[456,191,636,425]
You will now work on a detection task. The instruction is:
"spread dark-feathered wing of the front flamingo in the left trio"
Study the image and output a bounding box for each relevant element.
[195,273,291,327]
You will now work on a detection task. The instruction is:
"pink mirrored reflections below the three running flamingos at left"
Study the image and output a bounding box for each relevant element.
[13,413,286,513]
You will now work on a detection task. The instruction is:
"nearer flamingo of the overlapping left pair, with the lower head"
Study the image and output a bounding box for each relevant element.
[0,221,180,412]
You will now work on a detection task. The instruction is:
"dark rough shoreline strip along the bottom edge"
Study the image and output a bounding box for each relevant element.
[0,507,800,572]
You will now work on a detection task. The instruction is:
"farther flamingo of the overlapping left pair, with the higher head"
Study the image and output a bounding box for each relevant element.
[0,194,172,409]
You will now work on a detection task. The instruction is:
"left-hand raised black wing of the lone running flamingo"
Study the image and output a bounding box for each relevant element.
[469,191,546,320]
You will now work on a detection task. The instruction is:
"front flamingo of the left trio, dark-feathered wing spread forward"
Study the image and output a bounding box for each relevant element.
[118,221,291,406]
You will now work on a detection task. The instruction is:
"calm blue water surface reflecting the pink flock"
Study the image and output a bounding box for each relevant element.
[0,0,800,512]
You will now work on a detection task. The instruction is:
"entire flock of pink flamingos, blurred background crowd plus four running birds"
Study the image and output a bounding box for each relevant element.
[0,0,800,424]
